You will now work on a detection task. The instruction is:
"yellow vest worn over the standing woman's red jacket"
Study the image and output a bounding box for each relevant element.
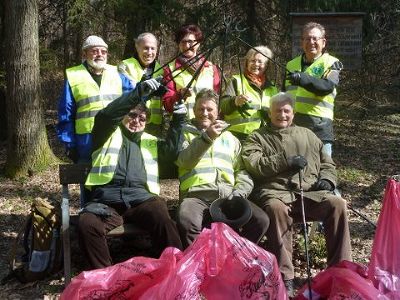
[168,60,214,119]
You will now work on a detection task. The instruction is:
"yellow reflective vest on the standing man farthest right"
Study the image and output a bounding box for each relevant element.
[285,53,338,120]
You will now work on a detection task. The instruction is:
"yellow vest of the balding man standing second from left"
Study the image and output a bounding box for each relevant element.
[122,57,163,125]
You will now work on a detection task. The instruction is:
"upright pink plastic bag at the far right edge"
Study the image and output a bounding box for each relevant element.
[368,179,400,299]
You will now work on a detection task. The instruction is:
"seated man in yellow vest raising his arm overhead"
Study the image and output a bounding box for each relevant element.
[79,79,186,268]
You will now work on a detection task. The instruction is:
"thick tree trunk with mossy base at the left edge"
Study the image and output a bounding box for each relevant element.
[5,0,56,178]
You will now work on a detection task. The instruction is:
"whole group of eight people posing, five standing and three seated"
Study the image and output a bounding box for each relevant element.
[57,22,351,293]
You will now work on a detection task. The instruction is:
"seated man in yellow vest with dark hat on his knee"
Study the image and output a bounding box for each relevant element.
[176,89,269,247]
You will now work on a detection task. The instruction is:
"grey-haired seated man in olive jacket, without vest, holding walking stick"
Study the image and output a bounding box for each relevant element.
[242,93,351,292]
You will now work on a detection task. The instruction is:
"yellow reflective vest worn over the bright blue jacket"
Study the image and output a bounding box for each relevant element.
[66,65,122,134]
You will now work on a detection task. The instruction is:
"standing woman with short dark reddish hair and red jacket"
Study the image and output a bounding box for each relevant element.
[163,25,220,119]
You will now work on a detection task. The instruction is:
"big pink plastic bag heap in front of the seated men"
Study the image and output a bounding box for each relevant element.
[61,223,287,300]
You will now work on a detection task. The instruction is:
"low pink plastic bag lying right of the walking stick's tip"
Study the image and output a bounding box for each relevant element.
[295,261,387,300]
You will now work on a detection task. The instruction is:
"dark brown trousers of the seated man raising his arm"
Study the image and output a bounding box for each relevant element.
[78,197,182,269]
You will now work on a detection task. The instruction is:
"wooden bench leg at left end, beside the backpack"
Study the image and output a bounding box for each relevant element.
[61,185,71,286]
